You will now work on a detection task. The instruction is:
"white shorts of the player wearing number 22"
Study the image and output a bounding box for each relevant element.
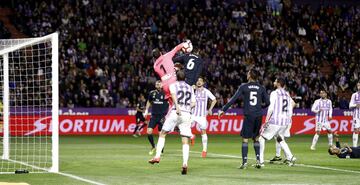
[162,111,192,137]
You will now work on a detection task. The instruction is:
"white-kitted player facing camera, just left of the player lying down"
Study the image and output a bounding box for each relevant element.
[310,90,333,150]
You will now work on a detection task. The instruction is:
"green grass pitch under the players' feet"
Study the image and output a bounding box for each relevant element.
[0,135,360,185]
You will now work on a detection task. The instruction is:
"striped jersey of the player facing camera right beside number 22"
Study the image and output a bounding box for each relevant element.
[193,87,215,117]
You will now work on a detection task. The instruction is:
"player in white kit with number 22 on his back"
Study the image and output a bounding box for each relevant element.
[149,70,196,175]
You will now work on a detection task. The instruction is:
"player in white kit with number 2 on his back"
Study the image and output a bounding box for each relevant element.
[256,78,296,168]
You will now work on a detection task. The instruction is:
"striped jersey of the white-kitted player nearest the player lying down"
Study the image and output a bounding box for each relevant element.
[311,98,333,123]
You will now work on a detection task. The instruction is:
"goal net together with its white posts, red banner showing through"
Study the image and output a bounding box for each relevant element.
[0,33,59,174]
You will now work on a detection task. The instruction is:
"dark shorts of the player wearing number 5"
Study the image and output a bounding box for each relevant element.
[241,115,262,138]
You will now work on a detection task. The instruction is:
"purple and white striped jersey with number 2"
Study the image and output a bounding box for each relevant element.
[268,88,292,126]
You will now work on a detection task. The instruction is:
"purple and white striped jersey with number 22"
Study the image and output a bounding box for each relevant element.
[169,81,196,113]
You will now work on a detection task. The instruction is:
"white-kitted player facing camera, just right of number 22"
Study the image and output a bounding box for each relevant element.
[192,77,216,158]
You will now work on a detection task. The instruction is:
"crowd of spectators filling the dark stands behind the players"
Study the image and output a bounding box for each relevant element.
[12,0,360,108]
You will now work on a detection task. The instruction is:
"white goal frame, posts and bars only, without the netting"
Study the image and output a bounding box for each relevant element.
[0,32,59,174]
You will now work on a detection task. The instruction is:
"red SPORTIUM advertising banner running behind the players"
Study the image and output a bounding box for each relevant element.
[0,115,353,136]
